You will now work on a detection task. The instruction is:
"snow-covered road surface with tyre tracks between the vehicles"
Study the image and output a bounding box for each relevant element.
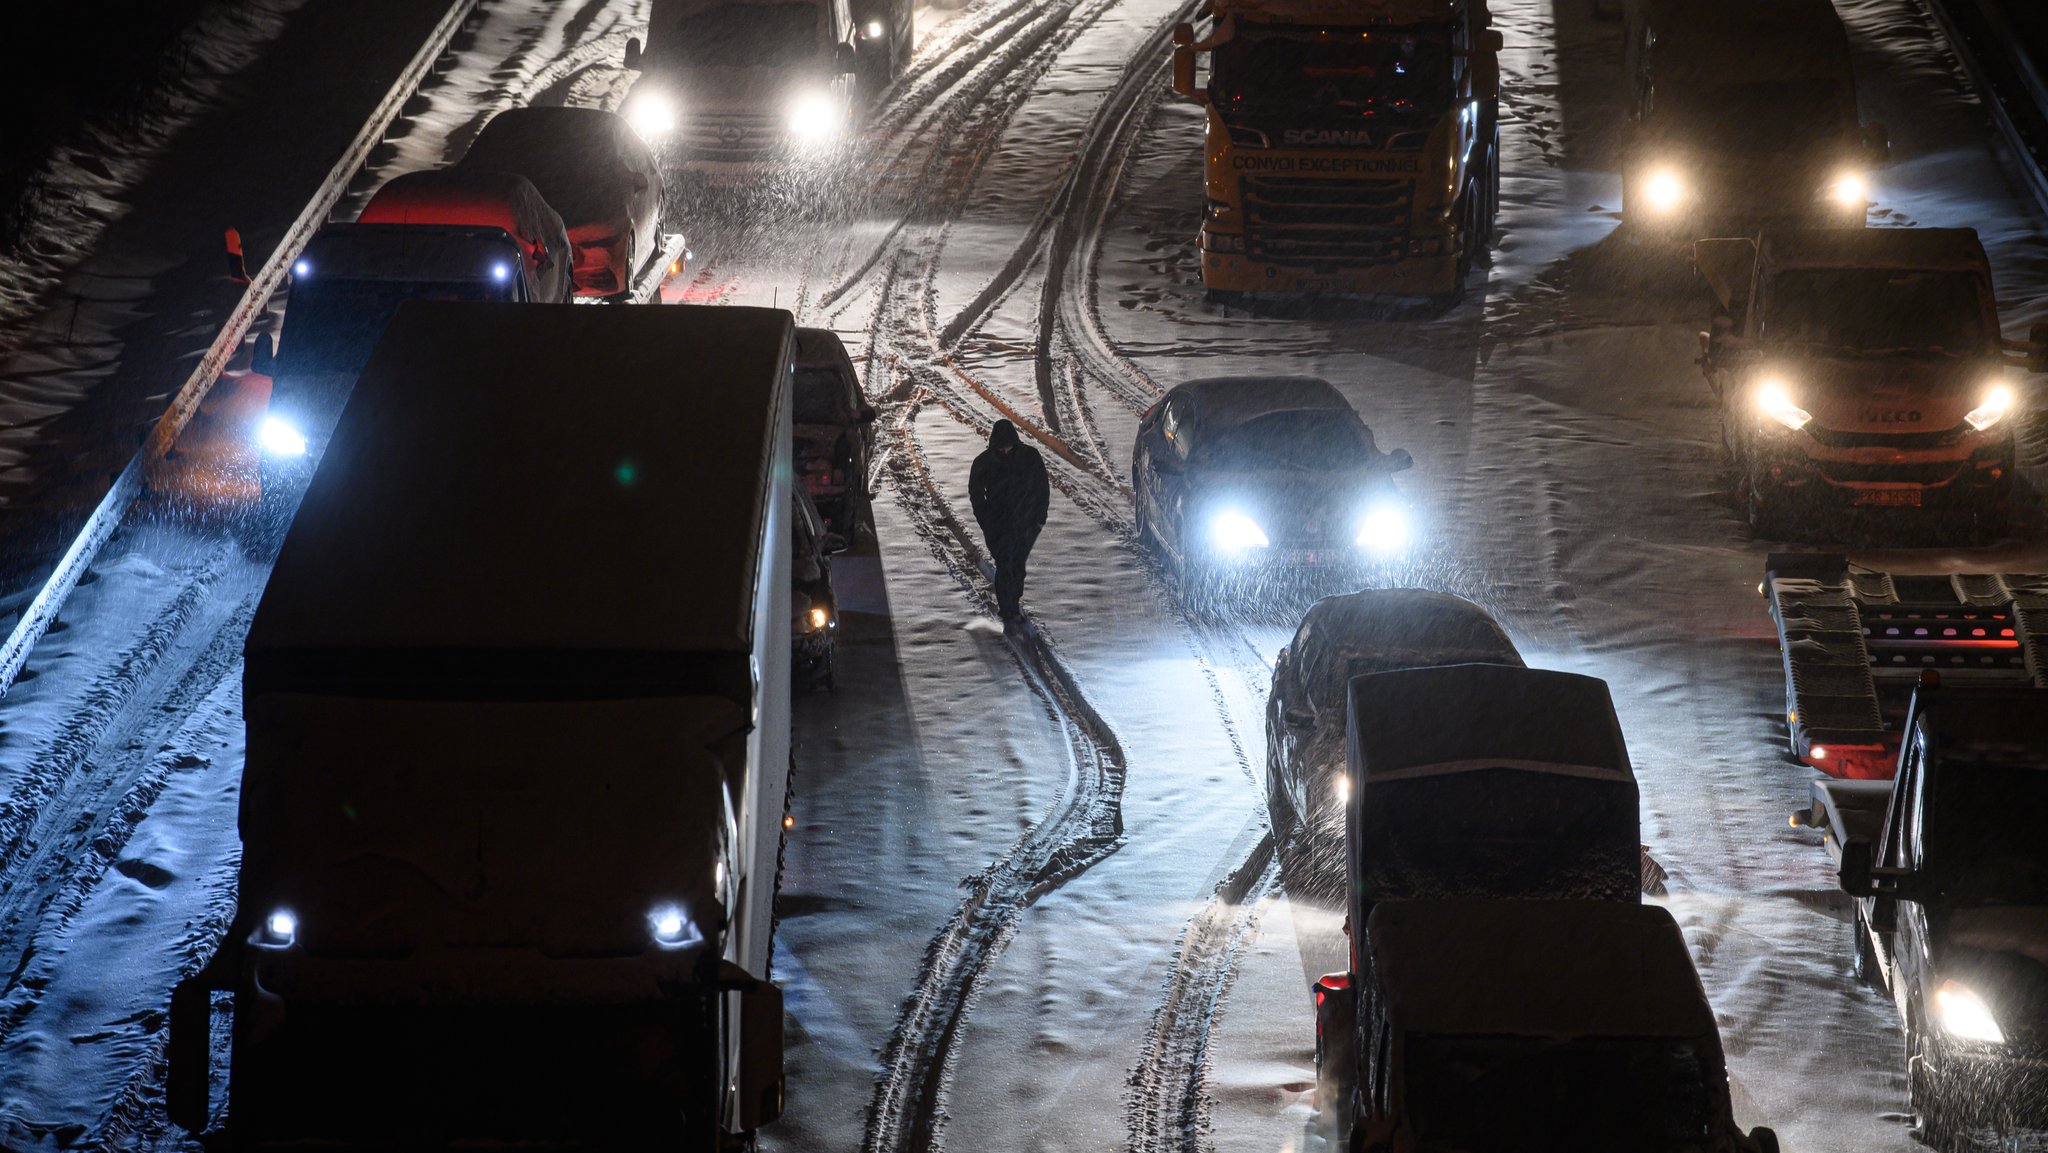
[0,0,2048,1153]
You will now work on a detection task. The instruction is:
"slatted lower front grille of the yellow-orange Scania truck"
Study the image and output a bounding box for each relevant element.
[1241,176,1415,264]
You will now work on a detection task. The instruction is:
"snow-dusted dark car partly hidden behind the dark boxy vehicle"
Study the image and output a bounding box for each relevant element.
[1266,588,1522,852]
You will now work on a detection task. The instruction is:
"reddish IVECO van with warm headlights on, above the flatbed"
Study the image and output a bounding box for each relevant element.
[1694,227,2044,537]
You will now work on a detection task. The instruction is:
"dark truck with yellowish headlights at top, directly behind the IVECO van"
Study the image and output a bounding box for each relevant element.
[1622,0,1888,240]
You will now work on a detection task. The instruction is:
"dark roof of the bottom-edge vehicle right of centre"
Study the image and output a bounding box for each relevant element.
[1366,901,1718,1038]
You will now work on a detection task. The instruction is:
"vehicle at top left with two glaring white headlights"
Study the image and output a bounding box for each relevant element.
[623,0,856,188]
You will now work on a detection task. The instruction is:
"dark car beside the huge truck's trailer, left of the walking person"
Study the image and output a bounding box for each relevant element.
[795,328,874,541]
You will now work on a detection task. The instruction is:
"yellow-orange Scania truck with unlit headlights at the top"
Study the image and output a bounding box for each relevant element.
[1174,0,1501,303]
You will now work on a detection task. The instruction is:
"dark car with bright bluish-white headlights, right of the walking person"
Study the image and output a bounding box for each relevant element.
[1130,377,1415,606]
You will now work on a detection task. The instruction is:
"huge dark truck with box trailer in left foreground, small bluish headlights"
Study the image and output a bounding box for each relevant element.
[170,303,795,1149]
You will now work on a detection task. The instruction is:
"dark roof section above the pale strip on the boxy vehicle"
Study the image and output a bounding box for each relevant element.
[1350,664,1634,782]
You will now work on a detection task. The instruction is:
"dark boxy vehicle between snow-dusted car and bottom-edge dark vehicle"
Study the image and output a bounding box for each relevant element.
[1315,664,1642,1133]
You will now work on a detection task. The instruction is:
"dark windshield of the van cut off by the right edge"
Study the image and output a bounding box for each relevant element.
[1927,760,2048,905]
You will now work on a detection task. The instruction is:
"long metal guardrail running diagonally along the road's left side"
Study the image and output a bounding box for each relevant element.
[0,0,483,696]
